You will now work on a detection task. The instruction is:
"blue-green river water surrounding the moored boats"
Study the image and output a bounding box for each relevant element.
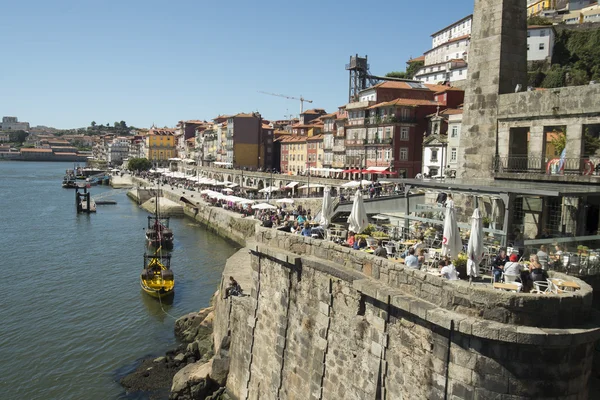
[0,161,235,400]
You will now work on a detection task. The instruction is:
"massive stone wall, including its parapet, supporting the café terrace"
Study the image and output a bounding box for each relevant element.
[216,229,599,399]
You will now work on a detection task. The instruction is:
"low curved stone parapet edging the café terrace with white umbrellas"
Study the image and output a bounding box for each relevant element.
[256,228,593,328]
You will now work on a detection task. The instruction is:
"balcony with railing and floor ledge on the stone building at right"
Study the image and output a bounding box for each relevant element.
[494,156,600,182]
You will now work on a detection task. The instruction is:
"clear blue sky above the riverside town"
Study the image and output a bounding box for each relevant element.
[0,0,473,128]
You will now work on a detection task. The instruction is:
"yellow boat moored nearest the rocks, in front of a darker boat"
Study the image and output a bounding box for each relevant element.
[140,253,175,299]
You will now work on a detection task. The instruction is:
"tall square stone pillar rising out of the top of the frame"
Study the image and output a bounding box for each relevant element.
[458,0,527,178]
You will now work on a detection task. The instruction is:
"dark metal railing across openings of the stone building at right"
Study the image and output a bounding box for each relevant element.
[494,156,600,175]
